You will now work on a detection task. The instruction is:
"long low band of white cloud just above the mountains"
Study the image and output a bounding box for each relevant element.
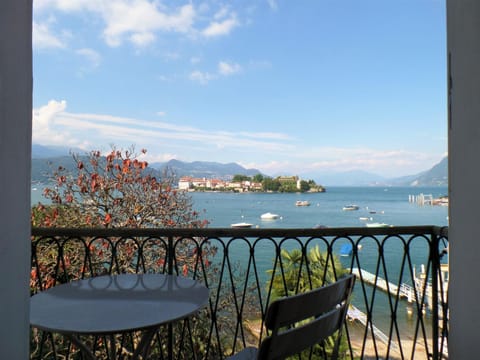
[33,100,438,177]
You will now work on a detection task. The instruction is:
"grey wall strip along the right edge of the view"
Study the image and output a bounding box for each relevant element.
[447,0,480,360]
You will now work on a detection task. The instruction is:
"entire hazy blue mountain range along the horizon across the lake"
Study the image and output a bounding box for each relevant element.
[32,145,448,186]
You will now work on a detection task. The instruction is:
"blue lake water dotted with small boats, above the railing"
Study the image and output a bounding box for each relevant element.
[192,187,448,228]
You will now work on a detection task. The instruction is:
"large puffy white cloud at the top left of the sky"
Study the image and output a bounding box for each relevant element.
[34,0,246,47]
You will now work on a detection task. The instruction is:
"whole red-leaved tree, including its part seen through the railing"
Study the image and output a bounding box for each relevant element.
[31,148,210,288]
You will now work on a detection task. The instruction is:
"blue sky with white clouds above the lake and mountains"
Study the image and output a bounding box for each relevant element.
[32,0,447,177]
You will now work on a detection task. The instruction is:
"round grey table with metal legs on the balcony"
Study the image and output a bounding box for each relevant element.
[30,274,209,359]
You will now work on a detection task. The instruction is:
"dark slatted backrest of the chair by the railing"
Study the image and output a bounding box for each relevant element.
[257,274,355,360]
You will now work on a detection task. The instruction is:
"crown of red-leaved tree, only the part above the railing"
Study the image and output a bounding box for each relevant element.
[32,148,207,228]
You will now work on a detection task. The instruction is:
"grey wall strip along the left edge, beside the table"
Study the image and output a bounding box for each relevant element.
[0,0,32,360]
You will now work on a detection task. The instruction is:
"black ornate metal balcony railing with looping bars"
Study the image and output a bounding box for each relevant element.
[31,226,448,359]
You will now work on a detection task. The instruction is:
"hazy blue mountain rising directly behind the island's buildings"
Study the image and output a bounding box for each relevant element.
[150,160,261,180]
